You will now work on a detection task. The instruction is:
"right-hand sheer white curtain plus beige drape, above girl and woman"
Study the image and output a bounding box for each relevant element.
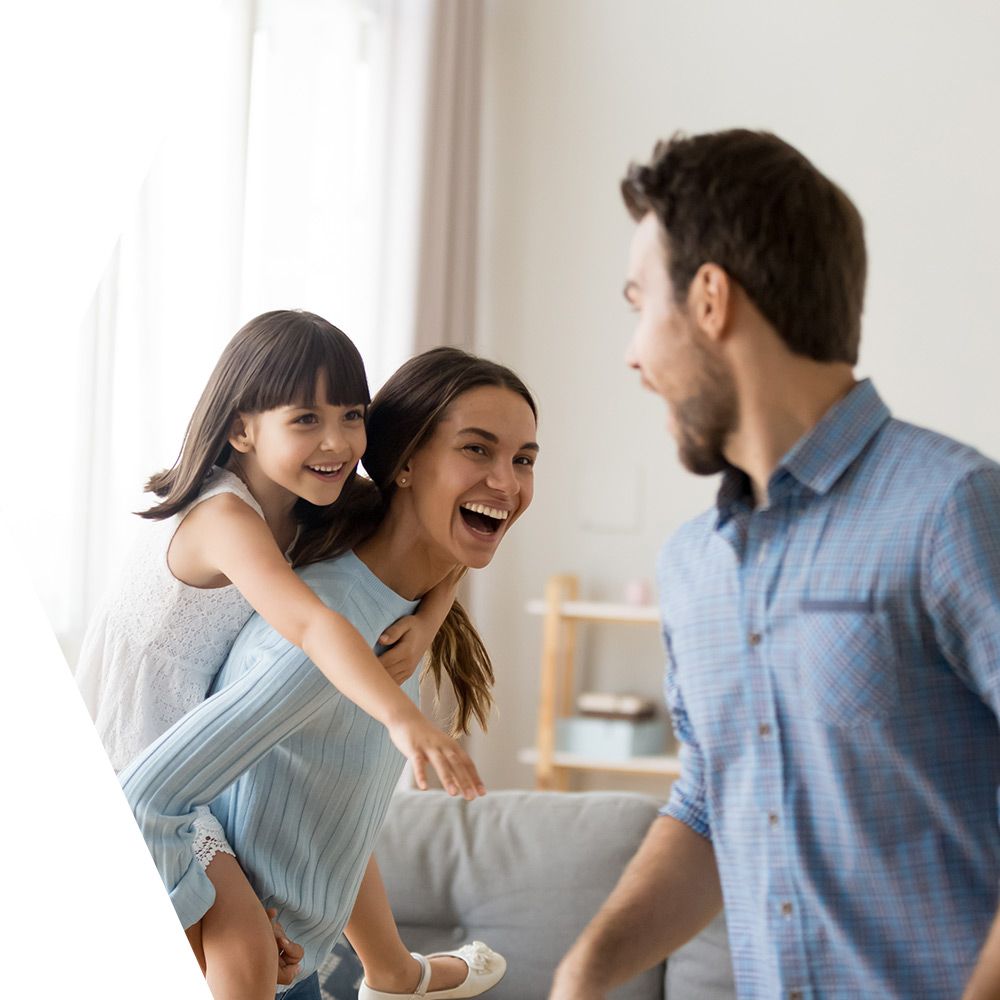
[243,0,482,388]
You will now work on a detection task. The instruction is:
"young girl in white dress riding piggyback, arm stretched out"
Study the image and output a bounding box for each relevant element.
[76,311,496,1000]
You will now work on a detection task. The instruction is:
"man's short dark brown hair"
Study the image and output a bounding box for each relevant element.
[621,129,867,365]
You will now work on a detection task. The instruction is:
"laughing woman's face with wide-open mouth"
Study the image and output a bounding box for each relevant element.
[393,386,538,569]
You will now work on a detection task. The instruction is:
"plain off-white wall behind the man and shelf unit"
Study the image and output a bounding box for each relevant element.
[473,0,1000,790]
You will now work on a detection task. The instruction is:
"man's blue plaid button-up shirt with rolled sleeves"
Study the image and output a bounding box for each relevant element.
[659,382,1000,1000]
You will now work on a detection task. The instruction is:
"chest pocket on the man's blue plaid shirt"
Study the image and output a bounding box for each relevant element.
[797,600,899,728]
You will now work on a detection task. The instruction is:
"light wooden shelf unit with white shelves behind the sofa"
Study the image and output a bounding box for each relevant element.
[518,574,680,791]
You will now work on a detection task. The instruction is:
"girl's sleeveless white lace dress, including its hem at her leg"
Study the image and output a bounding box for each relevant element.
[75,468,264,867]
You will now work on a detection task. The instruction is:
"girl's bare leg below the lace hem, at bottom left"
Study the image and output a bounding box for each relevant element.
[200,852,278,1000]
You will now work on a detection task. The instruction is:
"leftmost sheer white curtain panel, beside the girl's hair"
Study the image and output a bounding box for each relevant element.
[49,0,253,662]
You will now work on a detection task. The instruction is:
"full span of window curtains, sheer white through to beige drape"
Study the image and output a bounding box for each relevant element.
[41,0,486,662]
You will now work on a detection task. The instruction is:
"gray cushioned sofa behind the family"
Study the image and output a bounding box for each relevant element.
[352,791,735,1000]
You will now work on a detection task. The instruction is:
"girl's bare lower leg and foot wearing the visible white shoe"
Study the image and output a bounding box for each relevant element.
[344,857,469,994]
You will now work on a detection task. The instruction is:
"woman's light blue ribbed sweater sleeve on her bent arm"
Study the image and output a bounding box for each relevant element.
[121,640,336,927]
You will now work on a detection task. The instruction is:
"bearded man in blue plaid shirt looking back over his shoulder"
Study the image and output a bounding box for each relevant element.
[551,130,1000,1000]
